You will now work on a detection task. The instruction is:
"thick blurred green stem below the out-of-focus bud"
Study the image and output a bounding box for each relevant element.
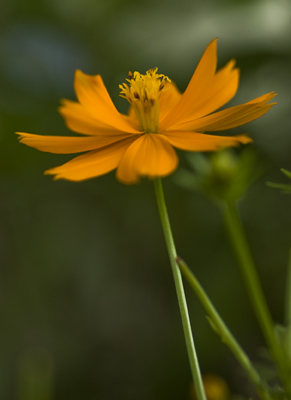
[224,202,288,381]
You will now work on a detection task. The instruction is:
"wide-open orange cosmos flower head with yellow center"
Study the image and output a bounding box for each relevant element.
[18,40,275,184]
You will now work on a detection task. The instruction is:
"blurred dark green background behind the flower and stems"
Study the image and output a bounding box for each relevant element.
[0,0,291,400]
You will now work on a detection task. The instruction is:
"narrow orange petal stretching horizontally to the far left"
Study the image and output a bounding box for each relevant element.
[17,132,132,154]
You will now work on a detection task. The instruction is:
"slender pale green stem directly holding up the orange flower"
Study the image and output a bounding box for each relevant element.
[154,178,206,400]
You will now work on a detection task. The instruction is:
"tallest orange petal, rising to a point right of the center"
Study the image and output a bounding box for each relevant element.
[161,39,217,130]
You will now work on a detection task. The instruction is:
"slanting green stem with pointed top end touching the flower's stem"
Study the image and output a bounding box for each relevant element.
[177,258,270,399]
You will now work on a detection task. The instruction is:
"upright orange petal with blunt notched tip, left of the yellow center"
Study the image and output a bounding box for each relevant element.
[74,70,140,133]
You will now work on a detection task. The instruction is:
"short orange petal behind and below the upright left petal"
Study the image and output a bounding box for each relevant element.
[59,99,140,136]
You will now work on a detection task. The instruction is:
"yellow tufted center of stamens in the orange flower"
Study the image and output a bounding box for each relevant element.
[119,68,171,133]
